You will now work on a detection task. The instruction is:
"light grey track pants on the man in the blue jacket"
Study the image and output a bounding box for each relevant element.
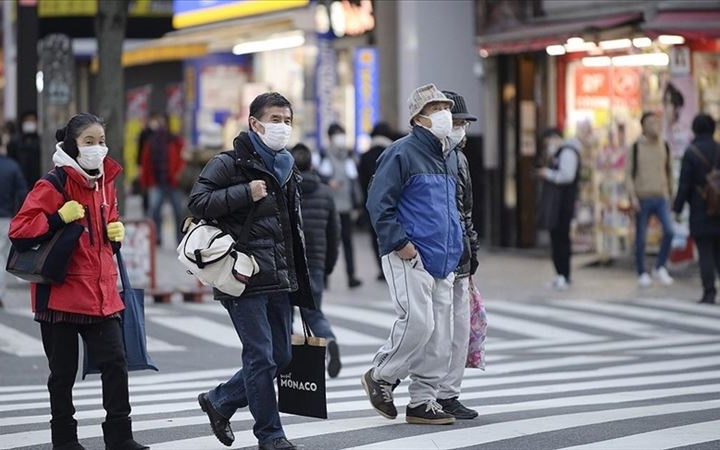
[373,252,455,407]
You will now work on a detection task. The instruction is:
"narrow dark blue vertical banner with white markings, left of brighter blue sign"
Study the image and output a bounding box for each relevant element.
[315,34,337,153]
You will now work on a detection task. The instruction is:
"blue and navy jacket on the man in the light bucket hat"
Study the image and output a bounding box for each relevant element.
[366,126,463,278]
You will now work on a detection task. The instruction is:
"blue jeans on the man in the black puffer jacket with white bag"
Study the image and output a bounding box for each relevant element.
[208,292,292,444]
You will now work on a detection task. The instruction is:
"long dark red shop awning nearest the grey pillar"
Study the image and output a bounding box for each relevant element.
[477,12,643,54]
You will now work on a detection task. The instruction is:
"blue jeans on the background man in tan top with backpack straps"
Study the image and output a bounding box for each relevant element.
[635,197,673,275]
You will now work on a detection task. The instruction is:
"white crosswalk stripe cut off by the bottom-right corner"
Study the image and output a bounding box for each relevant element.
[563,420,720,450]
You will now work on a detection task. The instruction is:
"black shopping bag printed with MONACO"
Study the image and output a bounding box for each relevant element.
[277,313,327,419]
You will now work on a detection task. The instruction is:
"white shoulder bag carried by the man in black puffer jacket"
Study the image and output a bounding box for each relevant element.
[177,213,260,297]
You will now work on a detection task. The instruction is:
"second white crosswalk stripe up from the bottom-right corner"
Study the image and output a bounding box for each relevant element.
[348,400,720,450]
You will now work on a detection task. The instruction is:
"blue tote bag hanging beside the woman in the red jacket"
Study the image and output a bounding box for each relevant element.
[83,250,158,380]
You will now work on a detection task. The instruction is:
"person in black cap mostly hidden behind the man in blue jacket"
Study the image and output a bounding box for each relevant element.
[437,91,480,419]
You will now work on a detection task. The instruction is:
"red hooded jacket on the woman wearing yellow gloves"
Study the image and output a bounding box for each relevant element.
[8,157,125,317]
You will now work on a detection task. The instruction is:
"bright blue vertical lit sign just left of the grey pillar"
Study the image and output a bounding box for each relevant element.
[354,47,380,153]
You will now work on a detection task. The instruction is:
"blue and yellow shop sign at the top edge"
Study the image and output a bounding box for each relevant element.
[173,0,310,28]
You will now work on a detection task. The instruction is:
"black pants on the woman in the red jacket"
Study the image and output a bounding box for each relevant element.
[40,319,130,445]
